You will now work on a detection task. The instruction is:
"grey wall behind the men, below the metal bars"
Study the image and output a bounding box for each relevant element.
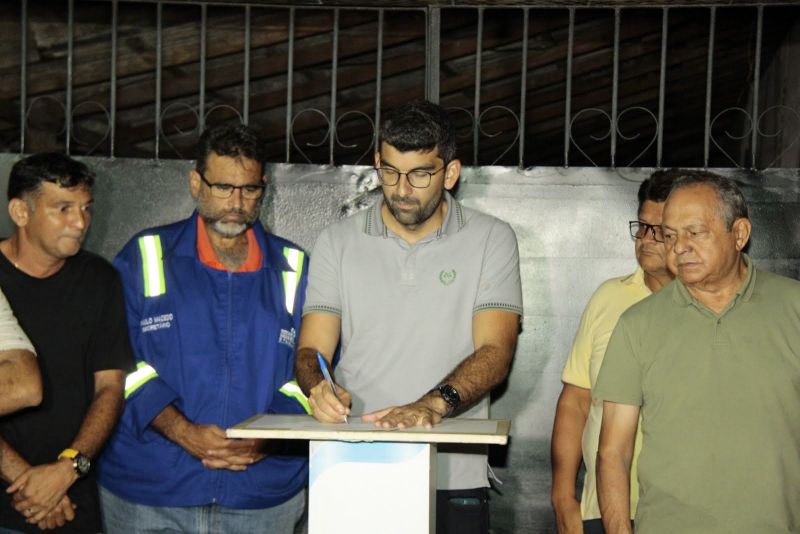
[0,155,800,533]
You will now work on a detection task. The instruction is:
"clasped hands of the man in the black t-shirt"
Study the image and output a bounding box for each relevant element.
[6,460,78,524]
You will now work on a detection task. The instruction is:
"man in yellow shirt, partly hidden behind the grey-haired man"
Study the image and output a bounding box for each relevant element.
[551,170,686,534]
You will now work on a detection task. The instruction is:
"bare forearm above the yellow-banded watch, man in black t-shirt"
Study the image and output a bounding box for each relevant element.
[71,372,124,458]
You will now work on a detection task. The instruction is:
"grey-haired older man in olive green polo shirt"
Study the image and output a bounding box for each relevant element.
[593,173,800,534]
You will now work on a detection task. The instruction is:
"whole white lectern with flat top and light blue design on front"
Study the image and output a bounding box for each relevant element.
[227,415,511,534]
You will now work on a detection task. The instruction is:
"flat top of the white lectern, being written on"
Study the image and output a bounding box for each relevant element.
[227,414,511,445]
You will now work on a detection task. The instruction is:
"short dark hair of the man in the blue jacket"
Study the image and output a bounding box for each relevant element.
[195,124,266,173]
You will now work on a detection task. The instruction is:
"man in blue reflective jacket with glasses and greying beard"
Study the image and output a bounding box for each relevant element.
[100,126,307,534]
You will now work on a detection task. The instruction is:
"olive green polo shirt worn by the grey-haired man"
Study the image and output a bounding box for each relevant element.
[592,256,800,534]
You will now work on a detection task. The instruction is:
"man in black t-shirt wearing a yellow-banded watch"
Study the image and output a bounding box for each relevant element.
[0,153,133,533]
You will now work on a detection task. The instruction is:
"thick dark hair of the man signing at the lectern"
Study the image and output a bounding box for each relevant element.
[376,100,456,164]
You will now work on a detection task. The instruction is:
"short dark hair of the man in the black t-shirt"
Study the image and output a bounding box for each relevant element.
[6,152,95,200]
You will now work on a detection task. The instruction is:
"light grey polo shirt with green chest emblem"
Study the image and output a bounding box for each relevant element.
[303,193,522,489]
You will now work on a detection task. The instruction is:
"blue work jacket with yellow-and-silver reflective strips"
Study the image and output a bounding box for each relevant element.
[99,213,308,509]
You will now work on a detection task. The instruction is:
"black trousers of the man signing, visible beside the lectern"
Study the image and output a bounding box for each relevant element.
[436,488,489,534]
